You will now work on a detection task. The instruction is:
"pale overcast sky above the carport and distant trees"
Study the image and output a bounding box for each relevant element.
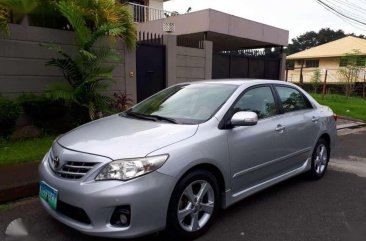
[164,0,366,42]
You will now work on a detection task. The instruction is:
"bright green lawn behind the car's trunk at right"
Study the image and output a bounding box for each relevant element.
[311,94,366,121]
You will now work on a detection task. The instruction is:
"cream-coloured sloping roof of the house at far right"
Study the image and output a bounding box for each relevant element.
[287,36,366,59]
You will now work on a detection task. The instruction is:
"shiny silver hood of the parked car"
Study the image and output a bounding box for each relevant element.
[57,115,198,160]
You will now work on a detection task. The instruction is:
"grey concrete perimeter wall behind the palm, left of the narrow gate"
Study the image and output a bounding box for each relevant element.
[0,24,136,98]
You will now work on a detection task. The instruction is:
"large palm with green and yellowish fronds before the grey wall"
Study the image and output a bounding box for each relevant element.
[45,0,136,120]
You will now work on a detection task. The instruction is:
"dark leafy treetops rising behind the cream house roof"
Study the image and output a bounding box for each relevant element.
[286,28,365,55]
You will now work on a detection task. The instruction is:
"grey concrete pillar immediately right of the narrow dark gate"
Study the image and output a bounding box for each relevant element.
[163,34,177,86]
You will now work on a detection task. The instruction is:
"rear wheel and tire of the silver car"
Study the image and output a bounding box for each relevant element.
[308,138,330,180]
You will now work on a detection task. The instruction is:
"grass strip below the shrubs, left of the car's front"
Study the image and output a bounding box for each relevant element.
[0,136,56,166]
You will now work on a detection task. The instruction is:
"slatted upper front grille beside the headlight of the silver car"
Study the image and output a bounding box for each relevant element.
[53,161,98,179]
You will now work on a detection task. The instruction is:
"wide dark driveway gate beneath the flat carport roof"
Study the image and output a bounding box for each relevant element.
[212,51,281,79]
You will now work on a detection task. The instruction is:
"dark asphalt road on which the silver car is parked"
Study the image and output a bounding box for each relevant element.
[0,128,366,241]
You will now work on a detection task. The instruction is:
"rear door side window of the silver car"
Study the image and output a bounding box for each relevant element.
[276,86,311,113]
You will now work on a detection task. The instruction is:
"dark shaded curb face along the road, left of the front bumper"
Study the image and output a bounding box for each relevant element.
[0,182,39,204]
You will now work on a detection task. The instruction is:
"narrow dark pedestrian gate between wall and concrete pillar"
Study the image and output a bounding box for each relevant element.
[136,35,166,102]
